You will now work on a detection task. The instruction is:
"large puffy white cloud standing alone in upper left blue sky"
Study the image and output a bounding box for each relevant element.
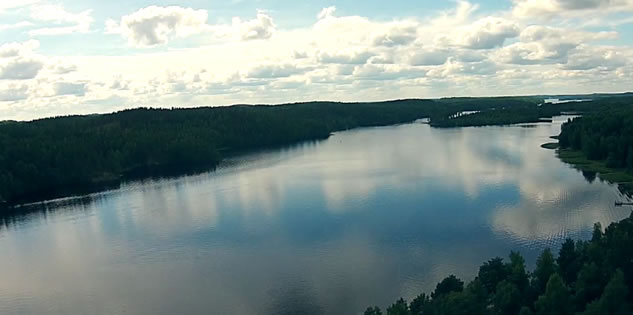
[106,6,208,47]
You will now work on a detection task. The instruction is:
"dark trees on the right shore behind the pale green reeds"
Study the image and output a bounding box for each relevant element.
[558,105,633,173]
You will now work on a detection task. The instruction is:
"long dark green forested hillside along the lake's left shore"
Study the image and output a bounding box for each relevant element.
[0,100,434,203]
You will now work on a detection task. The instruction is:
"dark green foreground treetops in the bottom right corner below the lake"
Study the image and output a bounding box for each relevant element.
[365,214,633,315]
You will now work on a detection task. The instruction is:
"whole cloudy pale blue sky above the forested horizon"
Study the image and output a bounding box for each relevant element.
[0,0,633,120]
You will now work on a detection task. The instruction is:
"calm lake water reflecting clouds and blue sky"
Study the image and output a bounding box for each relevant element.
[0,118,631,315]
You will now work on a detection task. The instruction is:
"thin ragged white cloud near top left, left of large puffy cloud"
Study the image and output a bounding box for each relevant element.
[29,4,94,36]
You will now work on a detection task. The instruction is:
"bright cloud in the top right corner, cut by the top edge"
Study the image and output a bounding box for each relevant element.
[513,0,633,18]
